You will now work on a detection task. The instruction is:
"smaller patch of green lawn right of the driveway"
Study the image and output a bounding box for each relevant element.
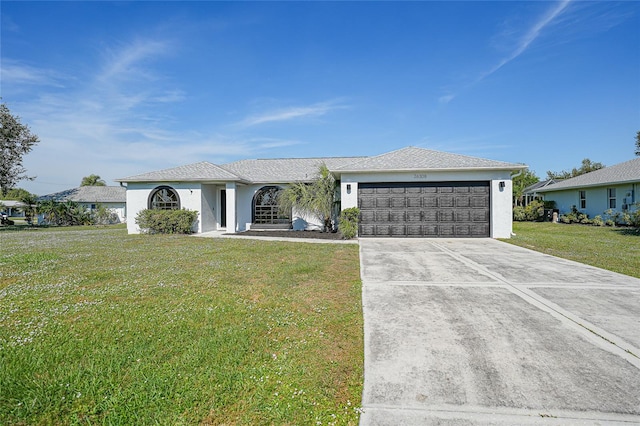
[504,222,640,278]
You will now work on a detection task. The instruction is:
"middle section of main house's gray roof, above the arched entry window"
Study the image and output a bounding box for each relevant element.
[221,157,366,183]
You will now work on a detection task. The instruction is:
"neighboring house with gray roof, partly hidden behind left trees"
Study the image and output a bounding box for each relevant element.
[38,186,127,222]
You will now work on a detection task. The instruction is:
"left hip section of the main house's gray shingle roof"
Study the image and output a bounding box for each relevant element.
[116,161,242,182]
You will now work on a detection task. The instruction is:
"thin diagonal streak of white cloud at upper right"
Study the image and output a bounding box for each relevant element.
[438,0,573,104]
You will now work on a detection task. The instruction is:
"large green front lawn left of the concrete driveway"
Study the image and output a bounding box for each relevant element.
[0,227,363,425]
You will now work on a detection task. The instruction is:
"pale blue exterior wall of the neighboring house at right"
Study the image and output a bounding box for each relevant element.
[542,184,640,218]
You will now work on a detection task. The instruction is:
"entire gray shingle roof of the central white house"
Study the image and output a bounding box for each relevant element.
[116,147,527,183]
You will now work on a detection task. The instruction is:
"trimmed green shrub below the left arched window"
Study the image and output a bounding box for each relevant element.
[136,209,198,234]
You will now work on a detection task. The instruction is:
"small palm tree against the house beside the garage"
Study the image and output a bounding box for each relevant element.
[278,164,337,232]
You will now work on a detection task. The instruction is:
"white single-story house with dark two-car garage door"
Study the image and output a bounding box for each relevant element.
[116,147,527,238]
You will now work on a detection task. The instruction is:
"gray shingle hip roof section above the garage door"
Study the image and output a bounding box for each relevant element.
[334,146,527,172]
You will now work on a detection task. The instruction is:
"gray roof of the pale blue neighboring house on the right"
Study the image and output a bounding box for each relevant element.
[538,158,640,192]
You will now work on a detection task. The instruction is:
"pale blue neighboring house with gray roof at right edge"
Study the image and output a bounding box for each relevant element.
[537,158,640,217]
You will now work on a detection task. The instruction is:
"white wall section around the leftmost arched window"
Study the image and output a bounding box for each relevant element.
[127,182,202,234]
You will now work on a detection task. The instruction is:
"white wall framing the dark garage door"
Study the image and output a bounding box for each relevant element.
[340,170,513,238]
